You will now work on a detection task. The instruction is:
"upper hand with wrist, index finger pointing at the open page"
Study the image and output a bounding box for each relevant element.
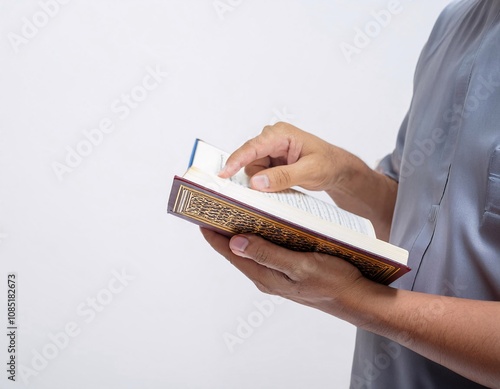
[219,122,398,240]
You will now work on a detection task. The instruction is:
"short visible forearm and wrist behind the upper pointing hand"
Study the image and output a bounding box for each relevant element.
[326,152,398,240]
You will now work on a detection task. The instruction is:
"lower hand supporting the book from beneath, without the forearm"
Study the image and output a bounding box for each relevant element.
[201,228,372,320]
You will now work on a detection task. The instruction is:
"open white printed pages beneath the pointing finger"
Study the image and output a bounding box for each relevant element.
[192,141,375,236]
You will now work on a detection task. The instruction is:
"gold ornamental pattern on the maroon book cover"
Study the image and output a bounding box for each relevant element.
[173,184,400,283]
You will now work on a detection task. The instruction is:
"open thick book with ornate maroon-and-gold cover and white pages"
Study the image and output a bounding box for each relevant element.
[167,139,410,285]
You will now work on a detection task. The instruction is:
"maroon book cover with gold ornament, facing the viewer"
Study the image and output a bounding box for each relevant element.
[168,176,410,284]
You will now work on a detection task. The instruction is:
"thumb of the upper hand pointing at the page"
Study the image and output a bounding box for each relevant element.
[250,159,312,192]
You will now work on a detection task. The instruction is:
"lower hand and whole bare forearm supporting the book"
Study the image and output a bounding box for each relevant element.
[201,228,500,388]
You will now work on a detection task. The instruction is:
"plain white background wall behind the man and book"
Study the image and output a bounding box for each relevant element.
[0,0,448,389]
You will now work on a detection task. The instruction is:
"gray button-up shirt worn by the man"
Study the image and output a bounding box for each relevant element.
[351,0,500,389]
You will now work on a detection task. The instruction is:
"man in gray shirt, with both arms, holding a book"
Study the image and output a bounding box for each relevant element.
[202,0,500,389]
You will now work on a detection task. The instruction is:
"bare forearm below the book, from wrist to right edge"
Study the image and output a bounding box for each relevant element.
[345,280,500,388]
